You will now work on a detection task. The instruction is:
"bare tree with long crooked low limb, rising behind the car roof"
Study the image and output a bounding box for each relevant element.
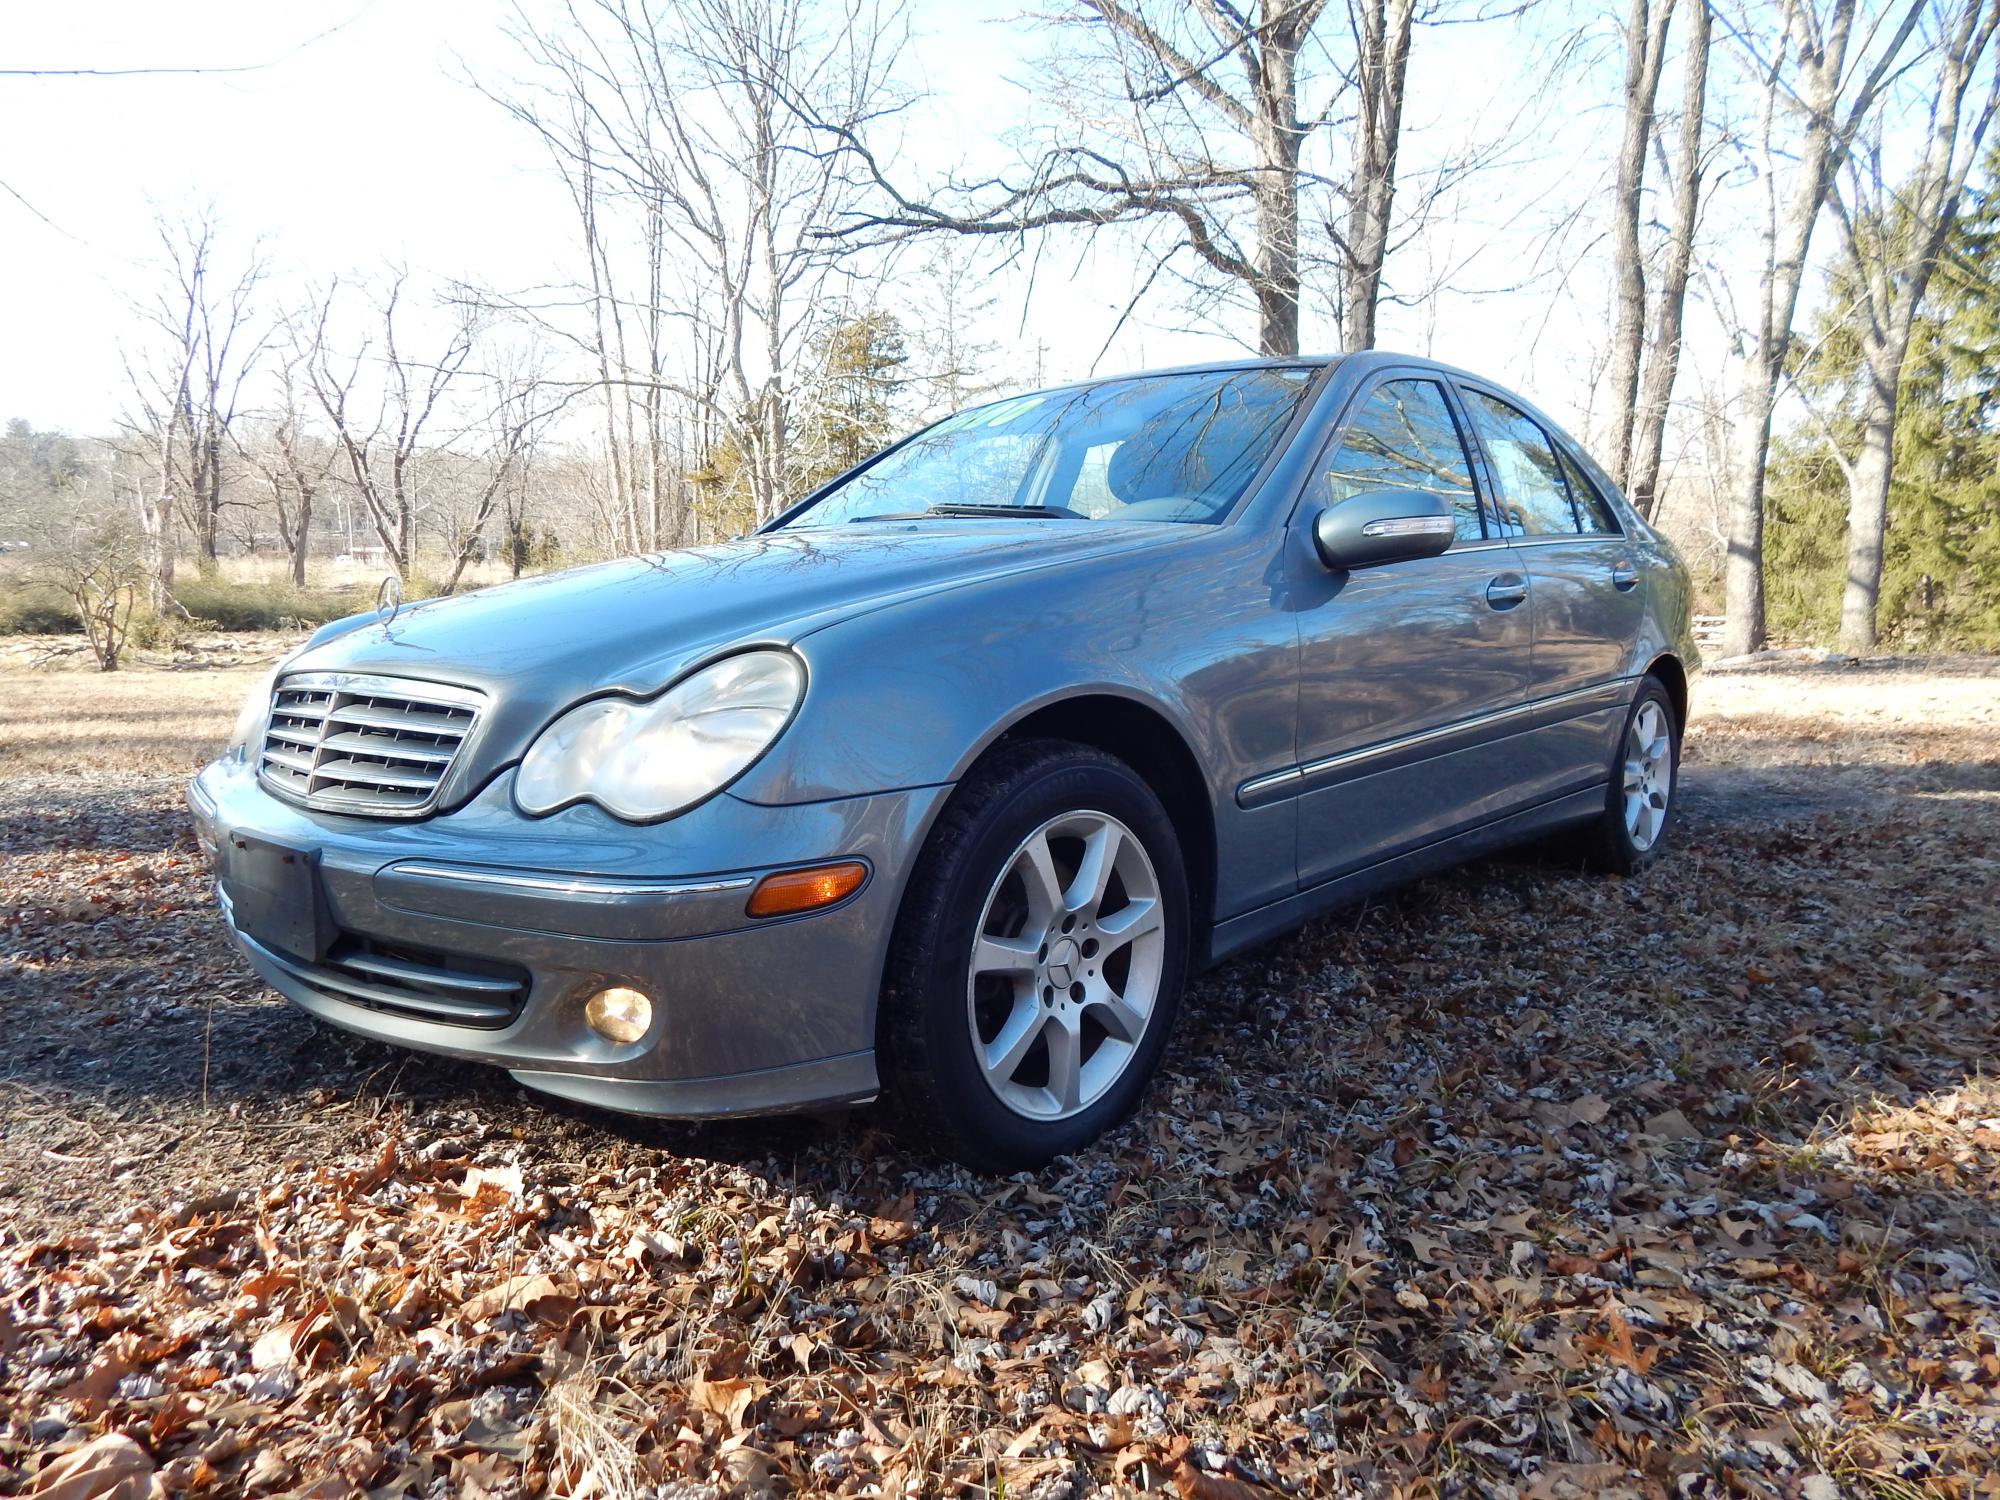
[820,0,1524,356]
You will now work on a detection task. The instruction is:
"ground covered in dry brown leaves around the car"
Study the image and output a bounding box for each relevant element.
[0,644,2000,1500]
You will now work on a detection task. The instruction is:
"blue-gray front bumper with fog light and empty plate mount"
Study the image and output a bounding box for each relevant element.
[188,760,950,1118]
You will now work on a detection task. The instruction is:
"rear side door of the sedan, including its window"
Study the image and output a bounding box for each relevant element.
[1460,380,1644,776]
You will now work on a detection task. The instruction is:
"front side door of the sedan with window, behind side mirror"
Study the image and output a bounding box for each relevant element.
[1294,372,1532,888]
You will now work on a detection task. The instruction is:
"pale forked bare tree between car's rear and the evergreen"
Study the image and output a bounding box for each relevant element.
[1722,0,1934,656]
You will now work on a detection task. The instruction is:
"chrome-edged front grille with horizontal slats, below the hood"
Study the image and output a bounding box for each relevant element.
[258,672,484,818]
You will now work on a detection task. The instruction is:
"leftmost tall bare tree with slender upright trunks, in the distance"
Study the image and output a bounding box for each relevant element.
[126,210,268,608]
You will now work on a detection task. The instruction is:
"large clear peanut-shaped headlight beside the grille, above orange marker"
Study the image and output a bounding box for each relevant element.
[514,650,806,822]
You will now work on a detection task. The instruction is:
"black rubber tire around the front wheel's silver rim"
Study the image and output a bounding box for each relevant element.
[876,740,1188,1172]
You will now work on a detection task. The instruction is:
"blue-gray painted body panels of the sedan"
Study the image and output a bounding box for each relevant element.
[190,354,1696,1114]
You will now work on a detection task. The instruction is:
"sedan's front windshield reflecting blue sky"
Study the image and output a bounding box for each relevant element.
[786,368,1314,528]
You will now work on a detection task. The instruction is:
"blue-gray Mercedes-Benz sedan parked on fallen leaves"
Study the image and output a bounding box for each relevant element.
[188,354,1696,1168]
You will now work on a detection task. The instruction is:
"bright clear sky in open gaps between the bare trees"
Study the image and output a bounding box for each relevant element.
[0,0,1640,432]
